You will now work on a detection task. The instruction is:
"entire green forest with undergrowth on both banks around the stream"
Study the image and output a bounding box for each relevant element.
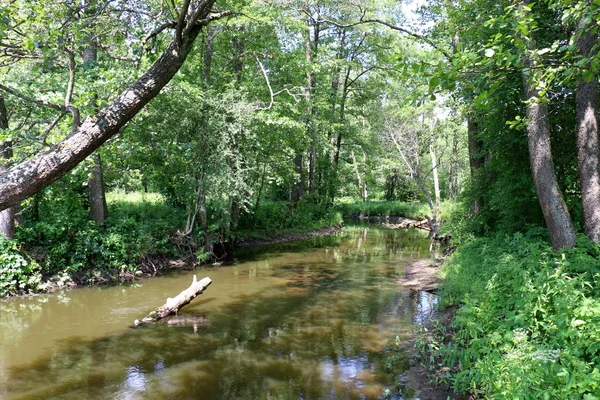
[0,0,600,400]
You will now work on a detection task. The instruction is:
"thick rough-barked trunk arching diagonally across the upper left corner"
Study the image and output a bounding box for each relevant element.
[0,0,225,210]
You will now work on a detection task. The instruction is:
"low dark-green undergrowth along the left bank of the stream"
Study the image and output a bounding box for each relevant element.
[0,192,342,297]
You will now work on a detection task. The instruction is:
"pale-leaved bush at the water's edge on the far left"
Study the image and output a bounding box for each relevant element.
[0,238,41,297]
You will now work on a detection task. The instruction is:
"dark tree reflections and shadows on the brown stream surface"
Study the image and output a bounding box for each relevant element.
[2,229,434,399]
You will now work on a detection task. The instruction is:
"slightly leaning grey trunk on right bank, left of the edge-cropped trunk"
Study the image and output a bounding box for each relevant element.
[520,3,575,250]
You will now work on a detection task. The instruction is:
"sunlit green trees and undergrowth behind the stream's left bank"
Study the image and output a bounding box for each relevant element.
[0,0,467,295]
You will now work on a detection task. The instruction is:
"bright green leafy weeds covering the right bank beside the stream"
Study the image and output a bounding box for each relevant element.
[426,228,600,400]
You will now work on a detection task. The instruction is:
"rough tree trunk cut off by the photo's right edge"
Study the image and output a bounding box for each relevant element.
[576,27,600,242]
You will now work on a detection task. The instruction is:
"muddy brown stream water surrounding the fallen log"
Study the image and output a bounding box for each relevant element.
[0,226,435,400]
